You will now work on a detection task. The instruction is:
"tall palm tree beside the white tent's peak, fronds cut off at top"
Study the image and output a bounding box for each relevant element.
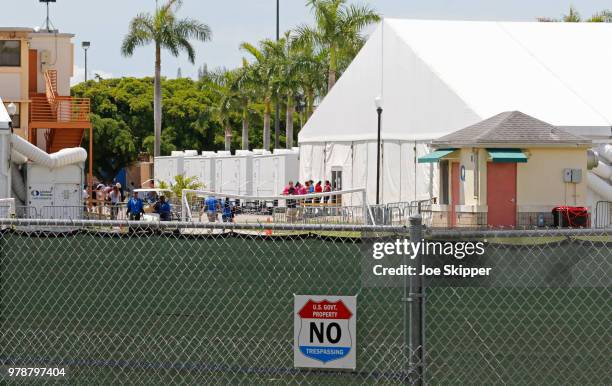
[296,0,380,91]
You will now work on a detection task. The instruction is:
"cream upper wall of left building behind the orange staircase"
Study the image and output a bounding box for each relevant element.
[30,33,74,96]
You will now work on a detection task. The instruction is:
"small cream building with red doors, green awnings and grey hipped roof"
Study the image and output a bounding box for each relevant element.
[418,111,592,227]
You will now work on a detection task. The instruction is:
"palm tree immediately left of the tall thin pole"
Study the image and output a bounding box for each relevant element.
[240,40,278,150]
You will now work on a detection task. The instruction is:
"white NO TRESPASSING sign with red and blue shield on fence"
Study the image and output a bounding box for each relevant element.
[293,295,357,369]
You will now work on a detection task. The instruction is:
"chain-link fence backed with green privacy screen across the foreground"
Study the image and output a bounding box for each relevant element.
[0,220,612,385]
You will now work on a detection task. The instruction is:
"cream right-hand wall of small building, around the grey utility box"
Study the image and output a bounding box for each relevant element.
[516,148,587,212]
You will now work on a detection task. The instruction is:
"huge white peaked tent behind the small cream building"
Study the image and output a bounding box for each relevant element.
[299,19,612,203]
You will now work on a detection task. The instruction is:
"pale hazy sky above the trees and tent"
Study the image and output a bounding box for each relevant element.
[0,0,612,83]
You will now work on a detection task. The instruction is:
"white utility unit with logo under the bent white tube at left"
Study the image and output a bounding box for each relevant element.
[26,163,84,220]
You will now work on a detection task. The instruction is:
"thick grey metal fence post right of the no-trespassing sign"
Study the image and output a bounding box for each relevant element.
[404,213,425,385]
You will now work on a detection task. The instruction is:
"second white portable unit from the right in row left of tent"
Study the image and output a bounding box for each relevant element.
[215,150,253,196]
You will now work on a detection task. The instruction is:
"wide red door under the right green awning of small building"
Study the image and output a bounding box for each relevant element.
[487,162,516,227]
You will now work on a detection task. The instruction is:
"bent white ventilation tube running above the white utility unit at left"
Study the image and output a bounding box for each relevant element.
[12,134,87,169]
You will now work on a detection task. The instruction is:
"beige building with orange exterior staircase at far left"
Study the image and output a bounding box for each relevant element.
[0,28,93,185]
